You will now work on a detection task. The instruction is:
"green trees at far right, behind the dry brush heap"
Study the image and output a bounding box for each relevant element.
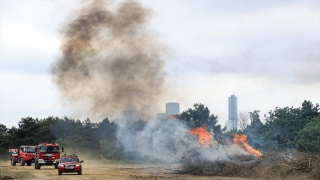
[238,101,320,153]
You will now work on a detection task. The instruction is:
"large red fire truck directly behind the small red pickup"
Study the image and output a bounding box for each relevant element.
[34,142,63,169]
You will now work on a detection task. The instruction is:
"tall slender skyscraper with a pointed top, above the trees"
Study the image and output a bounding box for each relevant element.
[228,94,238,130]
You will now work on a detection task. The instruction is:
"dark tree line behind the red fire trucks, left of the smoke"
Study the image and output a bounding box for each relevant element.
[0,117,121,159]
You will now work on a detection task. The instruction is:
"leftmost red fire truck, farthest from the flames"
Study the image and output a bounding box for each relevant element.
[9,146,36,166]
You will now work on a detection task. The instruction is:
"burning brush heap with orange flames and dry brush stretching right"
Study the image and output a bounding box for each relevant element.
[177,126,320,179]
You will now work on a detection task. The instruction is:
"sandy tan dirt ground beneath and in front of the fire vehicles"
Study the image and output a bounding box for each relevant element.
[0,161,248,180]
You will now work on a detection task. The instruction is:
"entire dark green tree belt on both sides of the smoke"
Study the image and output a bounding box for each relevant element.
[0,101,320,160]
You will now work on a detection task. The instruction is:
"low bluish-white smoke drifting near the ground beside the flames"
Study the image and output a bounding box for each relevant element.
[117,120,247,163]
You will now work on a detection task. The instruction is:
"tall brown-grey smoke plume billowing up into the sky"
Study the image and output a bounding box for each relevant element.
[51,0,165,120]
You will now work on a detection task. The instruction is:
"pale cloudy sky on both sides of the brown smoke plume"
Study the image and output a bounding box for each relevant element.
[0,0,320,128]
